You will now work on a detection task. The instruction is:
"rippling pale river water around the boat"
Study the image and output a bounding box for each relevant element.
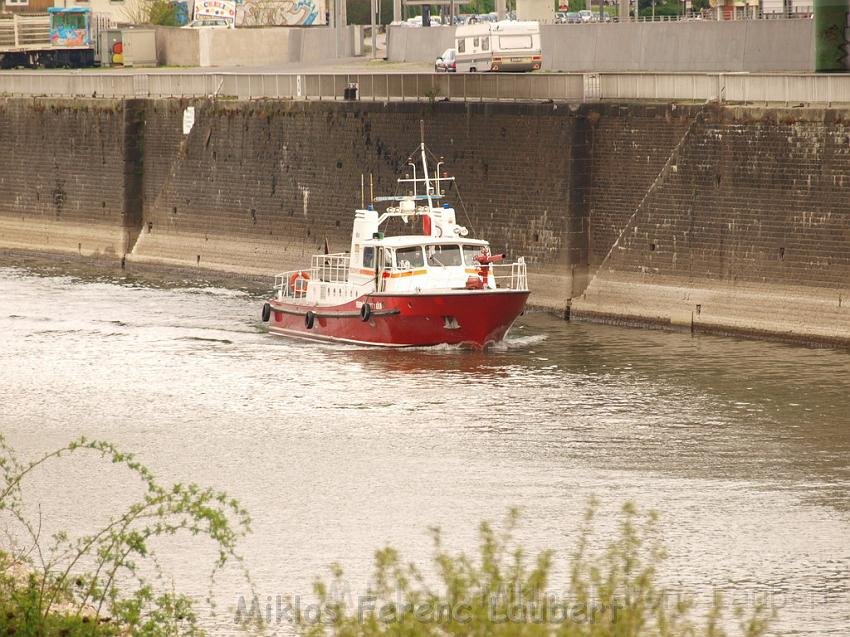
[0,260,850,635]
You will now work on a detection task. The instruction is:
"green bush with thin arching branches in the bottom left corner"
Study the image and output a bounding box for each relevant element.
[0,434,250,637]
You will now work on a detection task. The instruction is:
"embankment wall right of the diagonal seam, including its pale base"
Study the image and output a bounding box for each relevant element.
[573,107,850,342]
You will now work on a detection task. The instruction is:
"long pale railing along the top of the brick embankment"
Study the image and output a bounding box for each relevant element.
[0,72,850,105]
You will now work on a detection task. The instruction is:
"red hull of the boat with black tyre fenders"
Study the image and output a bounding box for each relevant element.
[269,290,529,349]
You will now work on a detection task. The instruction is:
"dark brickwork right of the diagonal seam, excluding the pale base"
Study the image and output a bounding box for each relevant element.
[592,109,850,287]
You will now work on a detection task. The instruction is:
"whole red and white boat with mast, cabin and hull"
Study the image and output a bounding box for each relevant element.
[262,143,529,349]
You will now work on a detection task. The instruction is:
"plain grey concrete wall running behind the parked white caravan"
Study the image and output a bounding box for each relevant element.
[387,20,814,73]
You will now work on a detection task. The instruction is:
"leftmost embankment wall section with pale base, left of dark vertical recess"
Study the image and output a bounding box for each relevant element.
[0,99,132,255]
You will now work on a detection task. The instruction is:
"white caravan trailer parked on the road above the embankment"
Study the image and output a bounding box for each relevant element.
[455,21,543,72]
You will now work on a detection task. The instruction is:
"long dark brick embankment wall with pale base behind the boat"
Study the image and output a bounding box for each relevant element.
[0,99,850,343]
